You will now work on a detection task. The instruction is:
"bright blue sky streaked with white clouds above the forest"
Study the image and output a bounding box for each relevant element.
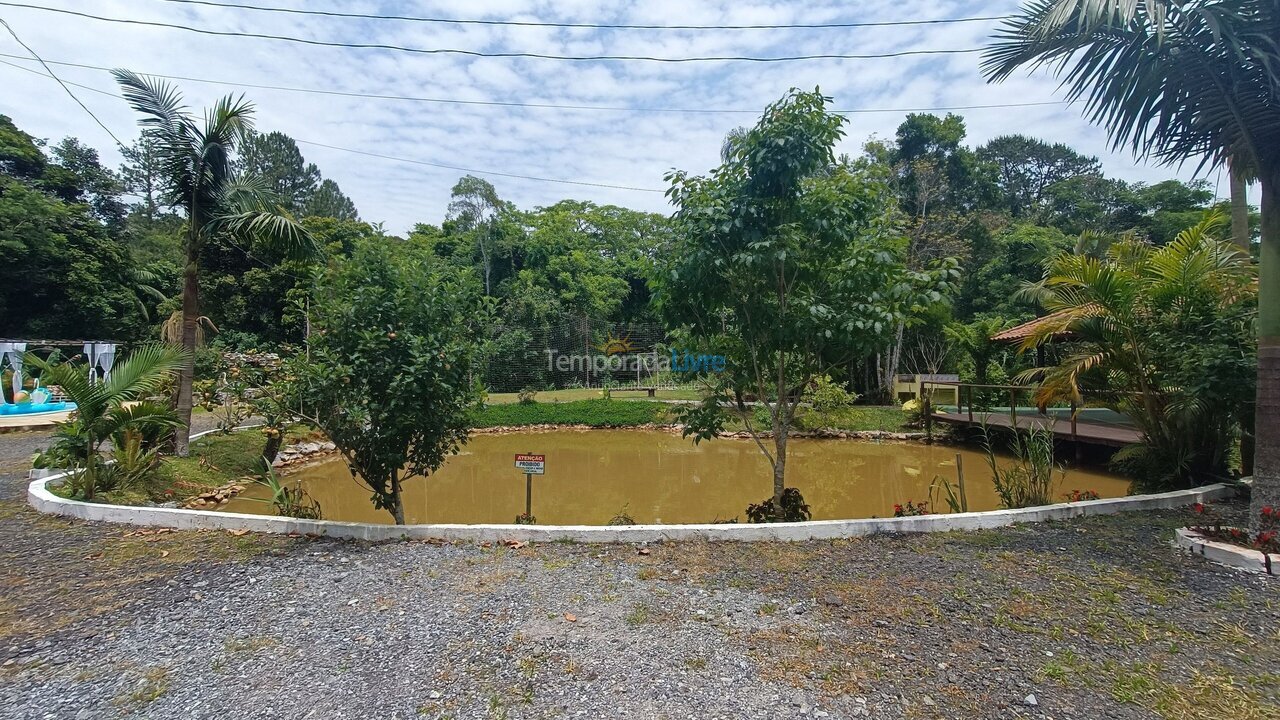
[0,0,1244,232]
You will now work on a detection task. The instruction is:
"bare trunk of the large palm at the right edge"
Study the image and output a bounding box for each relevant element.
[1249,170,1280,530]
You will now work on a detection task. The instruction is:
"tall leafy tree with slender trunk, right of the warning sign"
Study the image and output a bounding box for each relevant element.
[655,91,947,511]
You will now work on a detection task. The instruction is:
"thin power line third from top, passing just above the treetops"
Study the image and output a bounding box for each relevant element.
[0,53,1066,115]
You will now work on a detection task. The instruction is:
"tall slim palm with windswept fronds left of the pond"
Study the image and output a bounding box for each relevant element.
[113,70,317,456]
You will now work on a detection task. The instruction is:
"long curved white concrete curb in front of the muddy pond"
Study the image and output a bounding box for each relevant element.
[27,420,1235,543]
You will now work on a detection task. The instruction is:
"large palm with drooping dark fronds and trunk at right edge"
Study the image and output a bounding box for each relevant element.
[983,0,1280,524]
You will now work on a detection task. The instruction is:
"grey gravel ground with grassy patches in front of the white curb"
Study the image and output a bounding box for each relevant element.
[0,422,1280,720]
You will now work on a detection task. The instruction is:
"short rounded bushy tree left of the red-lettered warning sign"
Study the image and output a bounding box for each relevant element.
[296,238,480,524]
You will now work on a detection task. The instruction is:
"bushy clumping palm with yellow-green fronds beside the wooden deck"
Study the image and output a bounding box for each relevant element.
[1023,213,1256,487]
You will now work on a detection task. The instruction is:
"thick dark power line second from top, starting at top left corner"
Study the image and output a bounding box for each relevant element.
[0,3,982,63]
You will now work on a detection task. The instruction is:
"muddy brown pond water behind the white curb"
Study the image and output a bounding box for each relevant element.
[224,430,1129,525]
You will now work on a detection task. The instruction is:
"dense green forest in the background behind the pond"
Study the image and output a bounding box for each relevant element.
[0,114,1244,398]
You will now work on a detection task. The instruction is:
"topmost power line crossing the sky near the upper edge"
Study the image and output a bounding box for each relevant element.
[152,0,1012,29]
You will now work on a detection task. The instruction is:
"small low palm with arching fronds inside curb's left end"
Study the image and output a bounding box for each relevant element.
[27,345,186,500]
